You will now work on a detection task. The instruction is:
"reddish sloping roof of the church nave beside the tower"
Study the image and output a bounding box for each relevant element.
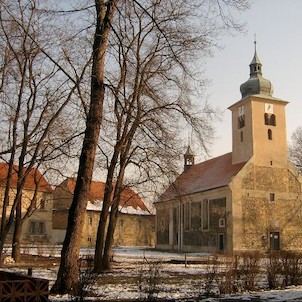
[160,153,245,201]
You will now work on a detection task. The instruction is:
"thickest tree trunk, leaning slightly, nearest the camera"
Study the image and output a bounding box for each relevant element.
[51,0,118,294]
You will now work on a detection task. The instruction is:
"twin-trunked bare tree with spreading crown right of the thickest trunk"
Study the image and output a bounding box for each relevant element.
[94,1,250,272]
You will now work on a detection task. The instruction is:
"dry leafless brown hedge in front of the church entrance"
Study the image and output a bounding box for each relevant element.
[201,251,302,296]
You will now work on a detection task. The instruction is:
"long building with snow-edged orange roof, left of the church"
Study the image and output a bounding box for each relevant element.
[53,178,155,246]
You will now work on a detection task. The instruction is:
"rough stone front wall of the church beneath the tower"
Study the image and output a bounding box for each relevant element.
[233,164,302,251]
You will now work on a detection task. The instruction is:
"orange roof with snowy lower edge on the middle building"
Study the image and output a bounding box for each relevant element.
[60,178,150,213]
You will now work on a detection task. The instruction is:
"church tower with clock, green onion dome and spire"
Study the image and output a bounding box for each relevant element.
[229,42,288,167]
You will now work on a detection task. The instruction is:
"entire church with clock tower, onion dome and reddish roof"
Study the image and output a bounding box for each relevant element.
[155,42,302,253]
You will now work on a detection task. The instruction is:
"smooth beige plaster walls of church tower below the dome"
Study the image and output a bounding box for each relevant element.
[229,95,287,167]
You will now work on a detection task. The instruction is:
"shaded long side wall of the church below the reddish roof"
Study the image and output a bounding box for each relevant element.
[156,187,232,252]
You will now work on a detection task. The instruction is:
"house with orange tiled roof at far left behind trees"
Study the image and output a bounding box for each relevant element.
[0,162,52,244]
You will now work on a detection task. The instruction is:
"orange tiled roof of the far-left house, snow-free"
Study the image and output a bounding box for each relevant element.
[0,162,52,192]
